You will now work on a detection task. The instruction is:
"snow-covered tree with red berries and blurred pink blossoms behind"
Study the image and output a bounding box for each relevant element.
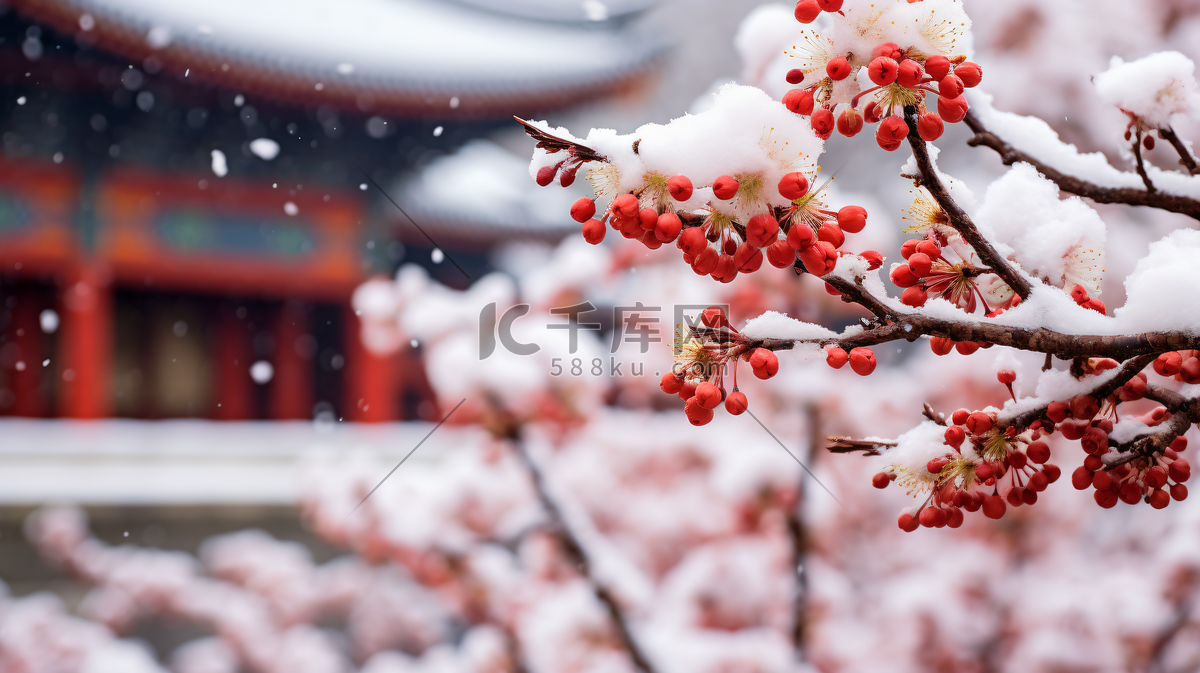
[11,0,1200,673]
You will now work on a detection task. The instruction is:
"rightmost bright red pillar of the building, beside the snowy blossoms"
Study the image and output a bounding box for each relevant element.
[343,305,398,422]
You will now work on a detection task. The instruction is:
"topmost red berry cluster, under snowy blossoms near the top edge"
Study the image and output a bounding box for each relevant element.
[784,5,983,151]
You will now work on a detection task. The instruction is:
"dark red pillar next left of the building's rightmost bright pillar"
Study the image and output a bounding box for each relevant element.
[266,301,313,420]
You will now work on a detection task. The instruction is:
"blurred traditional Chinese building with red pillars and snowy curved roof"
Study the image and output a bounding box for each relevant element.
[0,0,656,421]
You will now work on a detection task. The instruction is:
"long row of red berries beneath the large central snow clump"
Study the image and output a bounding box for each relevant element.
[571,173,883,283]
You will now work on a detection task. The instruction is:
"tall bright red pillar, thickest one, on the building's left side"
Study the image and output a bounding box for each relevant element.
[52,265,113,419]
